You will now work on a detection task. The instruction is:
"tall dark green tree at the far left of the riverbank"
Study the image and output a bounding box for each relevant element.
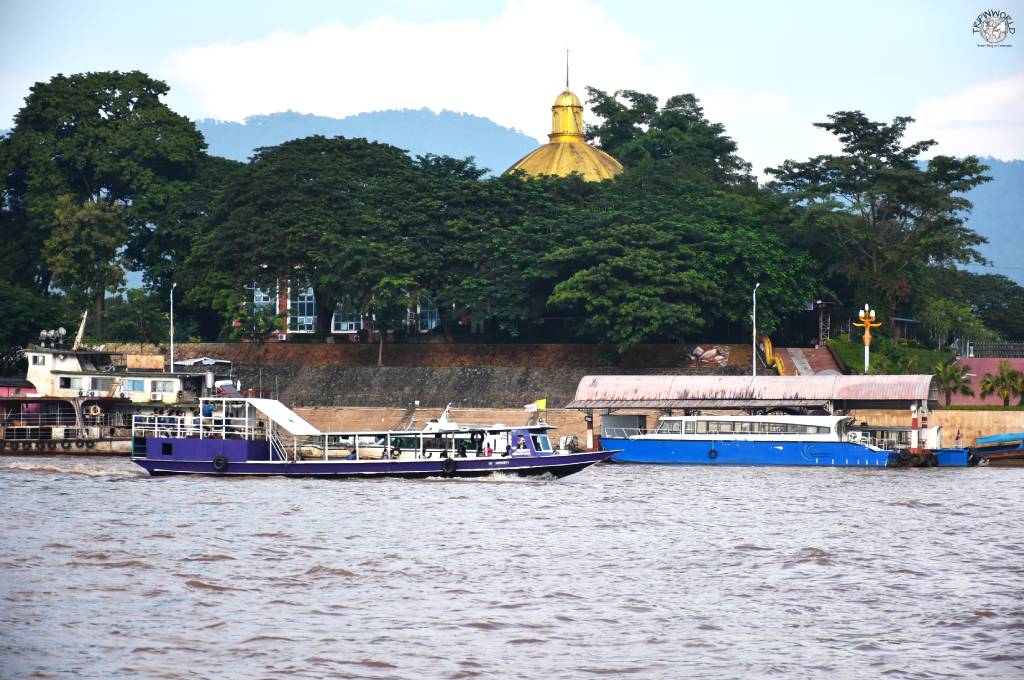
[0,71,205,337]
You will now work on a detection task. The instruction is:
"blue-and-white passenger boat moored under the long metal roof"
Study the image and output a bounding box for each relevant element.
[602,415,967,467]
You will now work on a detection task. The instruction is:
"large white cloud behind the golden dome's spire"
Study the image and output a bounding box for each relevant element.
[170,0,688,139]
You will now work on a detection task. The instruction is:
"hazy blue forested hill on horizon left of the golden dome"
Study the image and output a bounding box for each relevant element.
[196,109,539,174]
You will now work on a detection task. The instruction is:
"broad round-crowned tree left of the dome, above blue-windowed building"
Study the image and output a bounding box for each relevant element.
[187,136,421,338]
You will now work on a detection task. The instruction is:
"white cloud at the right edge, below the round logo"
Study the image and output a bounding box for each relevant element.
[907,76,1024,160]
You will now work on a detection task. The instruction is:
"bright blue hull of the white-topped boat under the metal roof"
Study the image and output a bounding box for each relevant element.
[602,437,896,467]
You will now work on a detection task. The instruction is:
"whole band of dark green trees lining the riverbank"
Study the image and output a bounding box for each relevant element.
[0,72,1024,372]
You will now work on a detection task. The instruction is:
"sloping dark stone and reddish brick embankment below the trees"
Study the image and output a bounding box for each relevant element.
[176,343,750,410]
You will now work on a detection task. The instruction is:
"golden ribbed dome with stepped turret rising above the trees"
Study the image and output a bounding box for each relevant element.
[506,89,623,181]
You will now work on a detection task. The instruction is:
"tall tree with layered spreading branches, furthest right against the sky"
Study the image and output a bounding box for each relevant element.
[767,111,989,318]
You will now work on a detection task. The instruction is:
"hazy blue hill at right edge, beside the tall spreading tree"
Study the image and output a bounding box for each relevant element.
[968,158,1024,284]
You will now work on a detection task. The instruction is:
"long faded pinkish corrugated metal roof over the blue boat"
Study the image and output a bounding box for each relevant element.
[568,375,938,409]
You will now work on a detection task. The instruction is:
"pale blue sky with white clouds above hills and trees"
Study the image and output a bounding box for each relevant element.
[0,0,1024,172]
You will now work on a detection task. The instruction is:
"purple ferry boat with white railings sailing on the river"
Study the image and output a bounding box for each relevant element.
[132,397,616,478]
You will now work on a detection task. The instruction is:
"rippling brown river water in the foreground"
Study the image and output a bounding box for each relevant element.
[0,457,1024,680]
